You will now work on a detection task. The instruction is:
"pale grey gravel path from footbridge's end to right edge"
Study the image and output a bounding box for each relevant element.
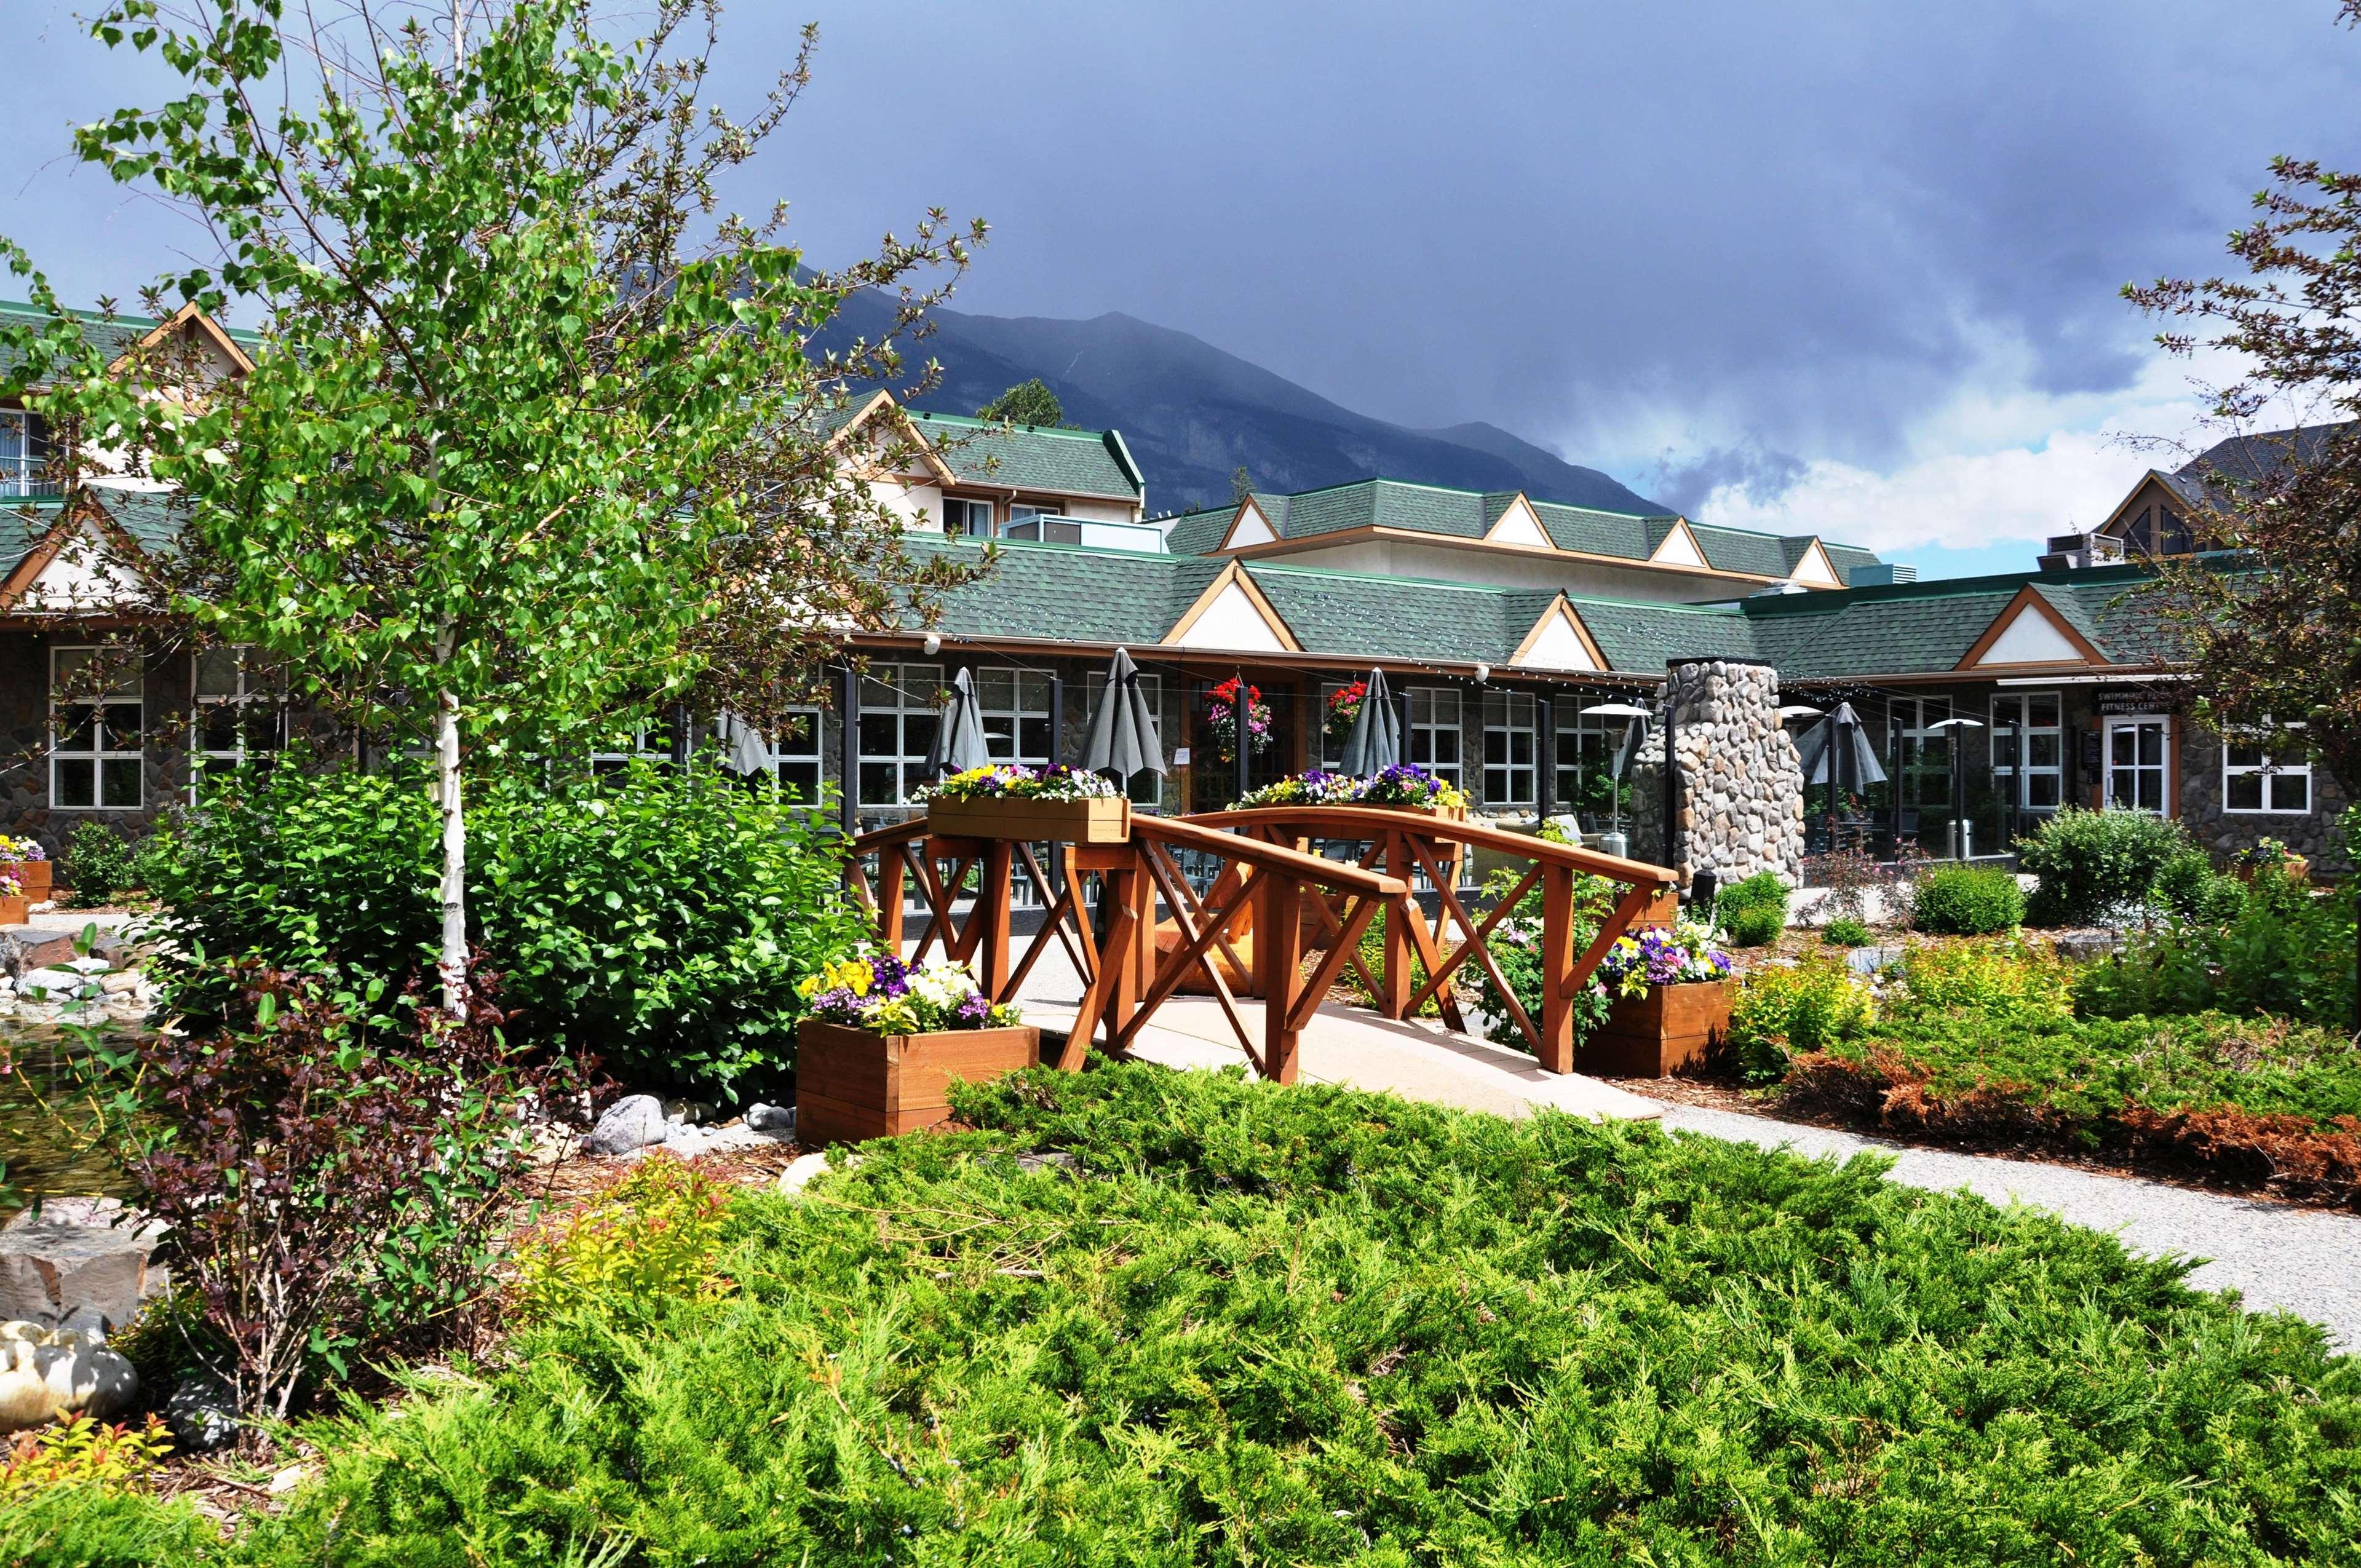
[1662,1105,2361,1351]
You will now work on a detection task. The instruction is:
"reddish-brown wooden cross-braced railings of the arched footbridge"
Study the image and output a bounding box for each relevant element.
[845,806,1674,1084]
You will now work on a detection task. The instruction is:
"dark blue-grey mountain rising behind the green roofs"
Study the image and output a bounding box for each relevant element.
[822,298,1669,512]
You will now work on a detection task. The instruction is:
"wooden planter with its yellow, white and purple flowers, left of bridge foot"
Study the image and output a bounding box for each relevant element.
[796,956,1041,1146]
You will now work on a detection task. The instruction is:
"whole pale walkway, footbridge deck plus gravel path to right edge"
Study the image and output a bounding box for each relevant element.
[972,930,2361,1351]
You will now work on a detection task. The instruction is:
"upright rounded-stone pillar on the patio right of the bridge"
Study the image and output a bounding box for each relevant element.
[1672,659,1804,888]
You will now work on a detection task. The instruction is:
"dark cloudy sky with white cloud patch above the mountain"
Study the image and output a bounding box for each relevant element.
[0,0,2361,571]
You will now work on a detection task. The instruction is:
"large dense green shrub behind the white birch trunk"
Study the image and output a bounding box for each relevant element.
[138,765,869,1101]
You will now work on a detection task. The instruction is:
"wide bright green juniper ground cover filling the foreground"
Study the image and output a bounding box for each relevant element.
[18,1067,2361,1568]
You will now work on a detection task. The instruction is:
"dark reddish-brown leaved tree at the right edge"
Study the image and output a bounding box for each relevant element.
[2125,0,2361,796]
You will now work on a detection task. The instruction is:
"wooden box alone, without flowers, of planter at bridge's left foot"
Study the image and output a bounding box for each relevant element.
[796,1018,1041,1147]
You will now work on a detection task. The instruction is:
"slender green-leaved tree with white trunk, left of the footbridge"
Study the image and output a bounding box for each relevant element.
[0,0,982,1013]
